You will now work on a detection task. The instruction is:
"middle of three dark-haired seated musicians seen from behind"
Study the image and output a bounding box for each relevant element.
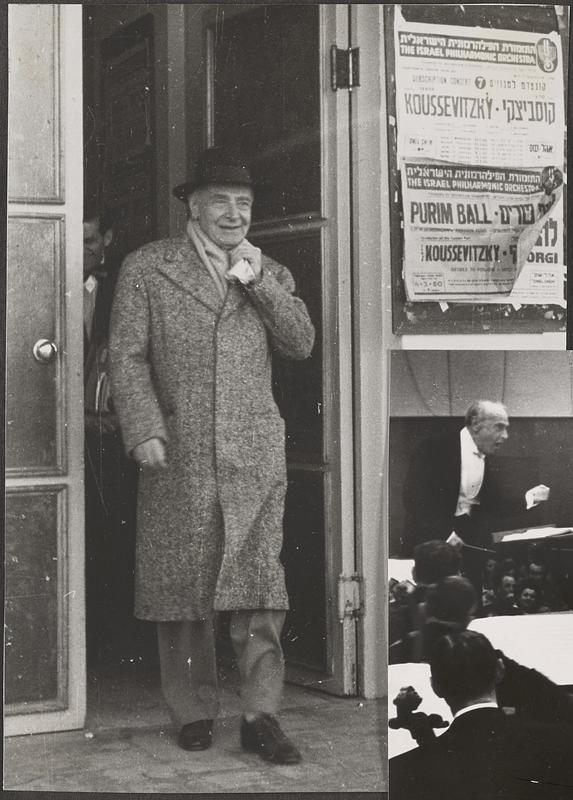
[419,576,573,725]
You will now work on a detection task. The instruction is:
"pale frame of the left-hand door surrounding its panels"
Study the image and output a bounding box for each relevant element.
[4,4,86,736]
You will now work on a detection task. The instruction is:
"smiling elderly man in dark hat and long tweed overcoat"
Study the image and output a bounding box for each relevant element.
[110,148,314,764]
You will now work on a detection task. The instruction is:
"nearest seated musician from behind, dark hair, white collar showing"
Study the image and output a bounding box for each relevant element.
[389,631,573,800]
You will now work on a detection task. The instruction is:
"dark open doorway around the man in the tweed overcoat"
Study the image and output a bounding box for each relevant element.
[83,4,358,708]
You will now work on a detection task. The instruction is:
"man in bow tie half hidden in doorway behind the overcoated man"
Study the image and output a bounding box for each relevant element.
[83,203,137,664]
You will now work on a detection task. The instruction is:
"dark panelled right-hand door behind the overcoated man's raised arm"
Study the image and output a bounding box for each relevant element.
[206,5,357,694]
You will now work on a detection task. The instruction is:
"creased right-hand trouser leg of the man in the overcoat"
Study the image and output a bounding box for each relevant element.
[230,609,286,714]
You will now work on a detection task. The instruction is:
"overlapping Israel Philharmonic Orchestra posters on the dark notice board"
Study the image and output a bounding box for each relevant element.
[394,9,565,308]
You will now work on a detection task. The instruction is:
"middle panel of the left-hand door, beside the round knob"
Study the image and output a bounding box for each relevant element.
[6,217,64,474]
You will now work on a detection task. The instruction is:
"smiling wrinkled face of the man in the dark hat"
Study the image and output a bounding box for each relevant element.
[188,186,253,250]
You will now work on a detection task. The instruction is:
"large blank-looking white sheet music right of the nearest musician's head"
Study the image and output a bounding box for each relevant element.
[469,611,573,686]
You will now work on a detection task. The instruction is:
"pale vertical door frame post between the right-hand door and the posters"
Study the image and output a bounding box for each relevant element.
[351,4,386,698]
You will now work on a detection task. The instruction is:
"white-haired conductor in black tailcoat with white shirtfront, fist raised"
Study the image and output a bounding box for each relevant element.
[403,400,549,583]
